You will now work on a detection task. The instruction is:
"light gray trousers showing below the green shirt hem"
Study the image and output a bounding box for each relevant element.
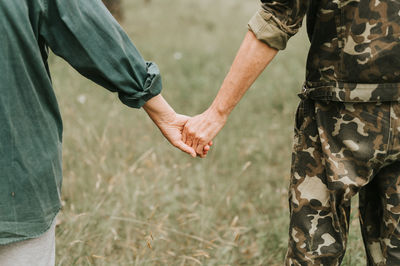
[0,222,56,266]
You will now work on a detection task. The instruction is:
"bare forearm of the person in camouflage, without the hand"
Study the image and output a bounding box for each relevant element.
[210,31,278,116]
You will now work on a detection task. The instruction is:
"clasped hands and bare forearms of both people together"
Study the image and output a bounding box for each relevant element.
[144,31,278,157]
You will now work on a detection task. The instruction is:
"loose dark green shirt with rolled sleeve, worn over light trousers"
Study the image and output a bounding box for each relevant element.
[0,0,161,244]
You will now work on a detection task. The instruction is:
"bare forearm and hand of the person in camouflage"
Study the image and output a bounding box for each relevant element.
[183,31,278,157]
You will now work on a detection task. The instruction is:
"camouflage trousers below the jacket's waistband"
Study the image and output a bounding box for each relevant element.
[285,99,400,266]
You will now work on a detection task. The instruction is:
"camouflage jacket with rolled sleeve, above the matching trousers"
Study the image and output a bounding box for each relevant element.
[249,0,400,102]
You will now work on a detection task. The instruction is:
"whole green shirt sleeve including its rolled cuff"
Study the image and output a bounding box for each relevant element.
[41,0,162,108]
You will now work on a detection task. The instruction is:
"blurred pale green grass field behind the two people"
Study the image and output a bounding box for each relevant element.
[51,0,365,265]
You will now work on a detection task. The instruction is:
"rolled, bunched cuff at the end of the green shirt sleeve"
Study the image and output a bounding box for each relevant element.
[118,62,162,108]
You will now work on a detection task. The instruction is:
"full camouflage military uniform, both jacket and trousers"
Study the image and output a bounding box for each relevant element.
[249,0,400,265]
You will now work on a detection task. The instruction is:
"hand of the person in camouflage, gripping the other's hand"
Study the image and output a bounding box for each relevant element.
[182,109,227,158]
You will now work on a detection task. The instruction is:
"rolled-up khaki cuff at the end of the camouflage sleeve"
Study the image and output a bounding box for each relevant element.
[248,9,290,50]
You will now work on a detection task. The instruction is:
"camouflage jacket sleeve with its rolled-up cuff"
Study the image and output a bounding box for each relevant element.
[248,0,310,50]
